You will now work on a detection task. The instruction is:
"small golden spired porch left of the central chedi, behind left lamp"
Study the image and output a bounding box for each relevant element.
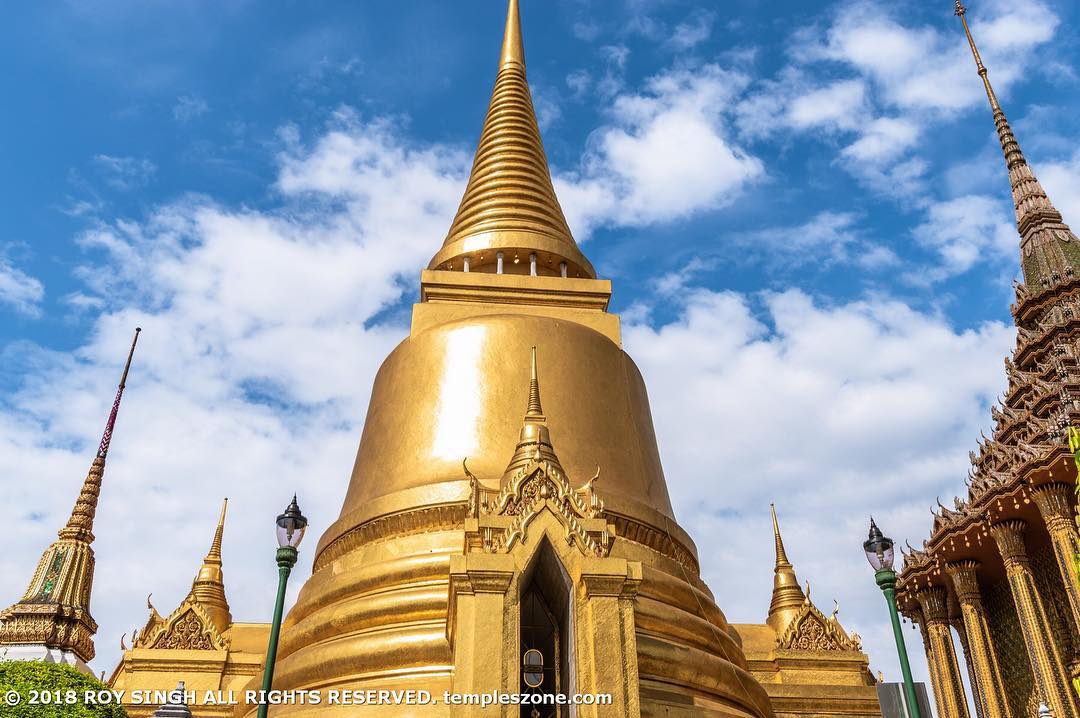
[108,499,270,718]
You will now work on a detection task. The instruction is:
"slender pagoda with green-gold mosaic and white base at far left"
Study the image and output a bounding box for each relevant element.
[0,329,141,673]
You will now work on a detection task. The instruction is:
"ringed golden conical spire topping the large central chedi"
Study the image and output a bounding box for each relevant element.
[429,0,596,279]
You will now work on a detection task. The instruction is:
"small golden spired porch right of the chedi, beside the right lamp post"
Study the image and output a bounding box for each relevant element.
[733,506,885,718]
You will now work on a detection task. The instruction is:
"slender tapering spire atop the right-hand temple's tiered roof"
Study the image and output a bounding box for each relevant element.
[956,0,1080,294]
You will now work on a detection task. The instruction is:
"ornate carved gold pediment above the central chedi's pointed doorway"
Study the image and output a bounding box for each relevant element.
[465,453,611,556]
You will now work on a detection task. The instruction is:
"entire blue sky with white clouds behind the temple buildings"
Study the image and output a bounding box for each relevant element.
[0,0,1080,703]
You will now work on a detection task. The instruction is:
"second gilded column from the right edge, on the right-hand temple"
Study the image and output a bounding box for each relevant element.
[990,518,1080,718]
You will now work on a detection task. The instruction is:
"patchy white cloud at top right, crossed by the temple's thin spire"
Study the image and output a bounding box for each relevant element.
[737,0,1058,201]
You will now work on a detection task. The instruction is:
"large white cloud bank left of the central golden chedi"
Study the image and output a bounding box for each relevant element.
[0,111,468,669]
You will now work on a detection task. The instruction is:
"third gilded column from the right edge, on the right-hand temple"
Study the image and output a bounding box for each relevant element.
[945,560,1012,718]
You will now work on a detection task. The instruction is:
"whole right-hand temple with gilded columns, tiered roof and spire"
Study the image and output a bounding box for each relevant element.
[899,0,1080,718]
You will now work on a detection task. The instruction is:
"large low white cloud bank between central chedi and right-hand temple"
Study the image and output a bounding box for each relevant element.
[623,289,1014,691]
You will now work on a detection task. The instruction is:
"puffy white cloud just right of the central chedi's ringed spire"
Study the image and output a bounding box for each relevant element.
[557,65,765,236]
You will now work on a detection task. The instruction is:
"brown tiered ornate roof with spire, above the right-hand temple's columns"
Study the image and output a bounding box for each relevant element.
[901,0,1080,595]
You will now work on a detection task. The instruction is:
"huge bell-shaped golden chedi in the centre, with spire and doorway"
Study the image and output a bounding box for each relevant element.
[250,0,772,718]
